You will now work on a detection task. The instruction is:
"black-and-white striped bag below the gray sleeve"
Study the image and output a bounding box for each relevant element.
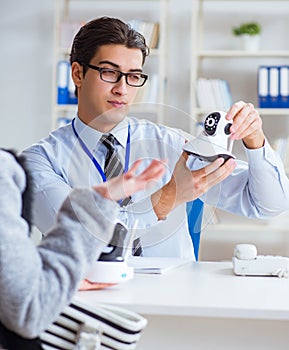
[40,300,147,350]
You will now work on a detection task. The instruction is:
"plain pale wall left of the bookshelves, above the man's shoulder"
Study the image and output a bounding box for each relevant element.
[0,0,53,150]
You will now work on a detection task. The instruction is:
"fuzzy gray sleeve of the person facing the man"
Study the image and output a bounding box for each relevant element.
[0,153,118,338]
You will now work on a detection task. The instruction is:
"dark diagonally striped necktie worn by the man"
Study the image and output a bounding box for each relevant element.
[100,134,142,256]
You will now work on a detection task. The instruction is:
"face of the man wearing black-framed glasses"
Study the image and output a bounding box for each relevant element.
[72,44,142,132]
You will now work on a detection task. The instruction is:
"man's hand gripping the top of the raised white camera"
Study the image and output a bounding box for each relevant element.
[226,101,265,149]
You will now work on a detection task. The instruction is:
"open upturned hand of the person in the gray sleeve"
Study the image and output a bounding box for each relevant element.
[94,160,165,201]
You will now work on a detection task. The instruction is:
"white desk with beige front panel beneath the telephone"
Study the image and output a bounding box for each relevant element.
[77,262,289,350]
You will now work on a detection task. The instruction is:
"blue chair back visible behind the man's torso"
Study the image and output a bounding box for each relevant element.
[187,199,204,261]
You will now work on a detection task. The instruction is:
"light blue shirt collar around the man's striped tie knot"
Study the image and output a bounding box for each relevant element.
[75,116,128,152]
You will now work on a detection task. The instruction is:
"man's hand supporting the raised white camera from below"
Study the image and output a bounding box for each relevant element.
[151,152,236,220]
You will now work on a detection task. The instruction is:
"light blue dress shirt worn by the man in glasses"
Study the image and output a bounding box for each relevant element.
[23,117,289,258]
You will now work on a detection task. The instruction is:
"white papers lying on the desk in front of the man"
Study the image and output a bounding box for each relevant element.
[127,256,193,274]
